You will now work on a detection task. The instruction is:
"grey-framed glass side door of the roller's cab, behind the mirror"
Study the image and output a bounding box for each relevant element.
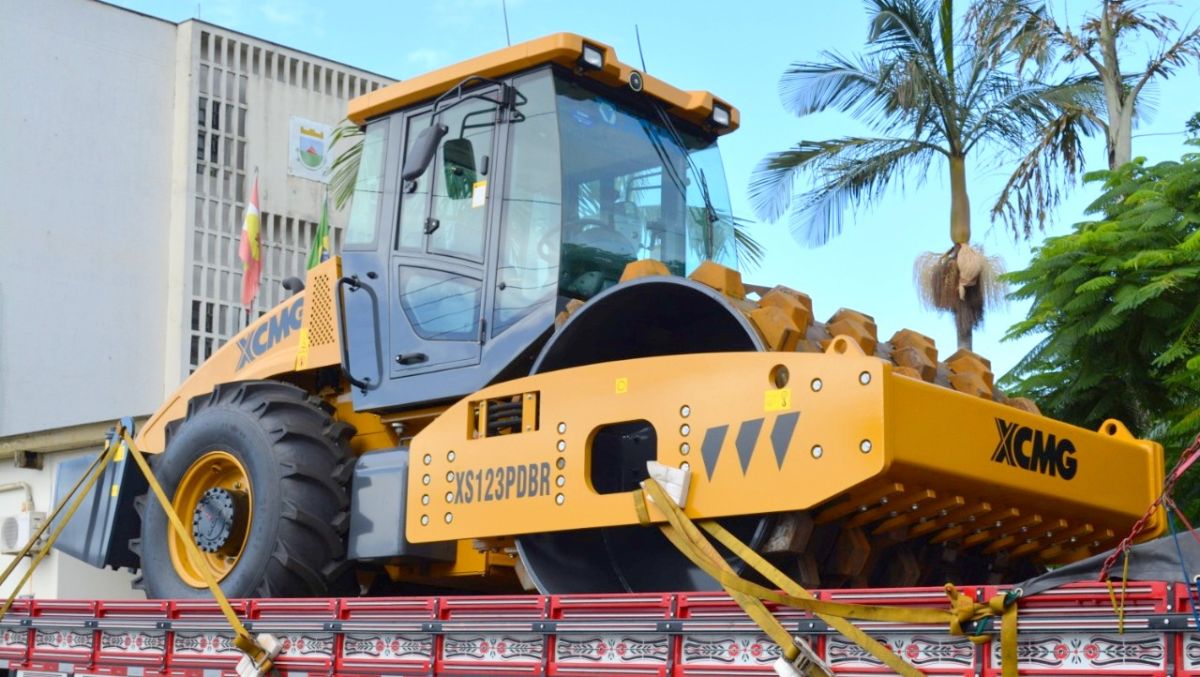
[389,91,499,378]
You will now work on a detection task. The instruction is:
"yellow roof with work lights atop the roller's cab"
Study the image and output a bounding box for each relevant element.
[347,32,739,134]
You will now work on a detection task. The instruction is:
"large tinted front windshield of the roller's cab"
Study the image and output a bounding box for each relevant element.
[554,76,737,299]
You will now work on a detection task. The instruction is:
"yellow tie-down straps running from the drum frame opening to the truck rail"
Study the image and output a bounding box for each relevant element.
[634,480,1016,677]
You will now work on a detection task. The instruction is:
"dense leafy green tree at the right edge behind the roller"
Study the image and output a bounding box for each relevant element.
[1001,143,1200,450]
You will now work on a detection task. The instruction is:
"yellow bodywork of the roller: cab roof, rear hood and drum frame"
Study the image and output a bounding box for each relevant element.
[112,34,1165,597]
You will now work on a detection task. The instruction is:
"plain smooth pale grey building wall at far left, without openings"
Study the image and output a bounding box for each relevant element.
[0,0,175,434]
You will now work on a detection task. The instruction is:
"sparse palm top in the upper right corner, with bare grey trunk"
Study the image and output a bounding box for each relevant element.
[1003,0,1200,170]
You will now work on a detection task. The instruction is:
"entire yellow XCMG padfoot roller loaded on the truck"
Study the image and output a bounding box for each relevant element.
[61,34,1163,598]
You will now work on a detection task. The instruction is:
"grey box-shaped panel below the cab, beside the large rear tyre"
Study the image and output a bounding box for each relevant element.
[348,449,455,562]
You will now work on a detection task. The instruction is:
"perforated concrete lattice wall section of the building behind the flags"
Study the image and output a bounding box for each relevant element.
[175,22,390,377]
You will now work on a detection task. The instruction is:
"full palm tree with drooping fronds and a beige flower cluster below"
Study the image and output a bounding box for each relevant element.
[750,0,1094,349]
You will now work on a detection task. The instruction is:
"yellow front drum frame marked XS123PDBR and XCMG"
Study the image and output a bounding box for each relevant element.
[406,337,1163,562]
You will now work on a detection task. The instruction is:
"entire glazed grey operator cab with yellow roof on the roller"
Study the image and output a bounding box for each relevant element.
[333,35,737,409]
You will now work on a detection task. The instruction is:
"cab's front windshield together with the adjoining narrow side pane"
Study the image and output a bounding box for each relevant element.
[477,68,737,334]
